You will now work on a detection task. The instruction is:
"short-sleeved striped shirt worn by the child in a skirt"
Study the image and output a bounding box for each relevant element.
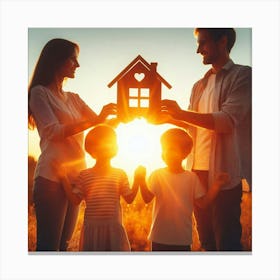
[73,168,131,221]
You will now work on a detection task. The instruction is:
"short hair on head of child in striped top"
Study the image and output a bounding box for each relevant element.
[85,124,117,158]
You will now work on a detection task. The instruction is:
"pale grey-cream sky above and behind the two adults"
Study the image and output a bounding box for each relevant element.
[28,28,252,165]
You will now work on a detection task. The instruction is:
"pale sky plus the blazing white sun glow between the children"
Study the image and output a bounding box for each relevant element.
[28,28,251,182]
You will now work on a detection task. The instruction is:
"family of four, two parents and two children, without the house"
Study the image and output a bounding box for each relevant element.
[28,28,252,251]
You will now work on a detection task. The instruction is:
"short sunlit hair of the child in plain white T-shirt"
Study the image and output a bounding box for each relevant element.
[160,128,193,157]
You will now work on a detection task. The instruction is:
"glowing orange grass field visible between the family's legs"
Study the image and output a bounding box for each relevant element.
[28,188,252,252]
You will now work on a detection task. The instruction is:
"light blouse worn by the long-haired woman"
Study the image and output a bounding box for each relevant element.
[29,85,96,182]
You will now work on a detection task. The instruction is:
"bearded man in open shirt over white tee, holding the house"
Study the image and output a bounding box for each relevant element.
[162,28,252,251]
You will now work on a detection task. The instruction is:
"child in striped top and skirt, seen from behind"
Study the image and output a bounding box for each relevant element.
[61,125,139,251]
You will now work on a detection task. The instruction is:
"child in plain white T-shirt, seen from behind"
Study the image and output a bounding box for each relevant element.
[138,128,228,251]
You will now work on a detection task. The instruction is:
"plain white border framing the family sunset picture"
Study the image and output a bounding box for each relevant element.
[0,0,280,280]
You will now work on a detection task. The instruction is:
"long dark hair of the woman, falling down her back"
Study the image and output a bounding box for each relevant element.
[28,39,79,129]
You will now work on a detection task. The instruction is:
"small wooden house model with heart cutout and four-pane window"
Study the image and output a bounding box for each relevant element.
[108,55,171,122]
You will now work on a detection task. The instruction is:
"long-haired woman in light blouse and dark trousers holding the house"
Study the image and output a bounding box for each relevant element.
[28,39,116,251]
